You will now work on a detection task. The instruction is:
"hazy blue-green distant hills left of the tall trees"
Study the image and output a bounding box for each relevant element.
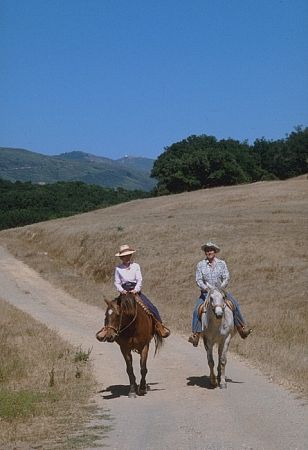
[0,147,156,191]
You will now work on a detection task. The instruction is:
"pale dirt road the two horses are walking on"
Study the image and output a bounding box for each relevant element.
[0,247,308,450]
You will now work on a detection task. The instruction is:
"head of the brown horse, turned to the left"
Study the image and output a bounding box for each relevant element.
[96,294,135,342]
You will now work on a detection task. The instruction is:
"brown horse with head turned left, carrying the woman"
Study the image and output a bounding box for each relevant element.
[96,293,163,397]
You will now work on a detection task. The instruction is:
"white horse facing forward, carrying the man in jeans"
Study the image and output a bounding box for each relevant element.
[201,289,236,389]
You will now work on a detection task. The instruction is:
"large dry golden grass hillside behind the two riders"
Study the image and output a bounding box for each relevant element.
[0,177,308,394]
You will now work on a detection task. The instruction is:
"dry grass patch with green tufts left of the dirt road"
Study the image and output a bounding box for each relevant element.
[0,299,105,450]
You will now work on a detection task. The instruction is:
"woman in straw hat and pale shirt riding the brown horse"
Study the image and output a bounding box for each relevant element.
[114,244,170,338]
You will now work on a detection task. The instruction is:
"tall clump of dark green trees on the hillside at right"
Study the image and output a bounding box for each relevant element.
[151,127,308,195]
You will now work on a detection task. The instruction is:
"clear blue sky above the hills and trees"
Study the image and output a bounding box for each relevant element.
[0,0,308,159]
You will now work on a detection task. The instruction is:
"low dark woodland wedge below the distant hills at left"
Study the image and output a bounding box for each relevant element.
[0,179,150,230]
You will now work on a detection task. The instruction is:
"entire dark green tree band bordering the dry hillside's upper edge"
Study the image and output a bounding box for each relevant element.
[0,127,308,230]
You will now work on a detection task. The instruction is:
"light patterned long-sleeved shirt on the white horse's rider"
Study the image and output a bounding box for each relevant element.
[196,258,230,291]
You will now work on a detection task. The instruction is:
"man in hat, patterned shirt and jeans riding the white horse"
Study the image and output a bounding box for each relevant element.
[188,242,252,347]
